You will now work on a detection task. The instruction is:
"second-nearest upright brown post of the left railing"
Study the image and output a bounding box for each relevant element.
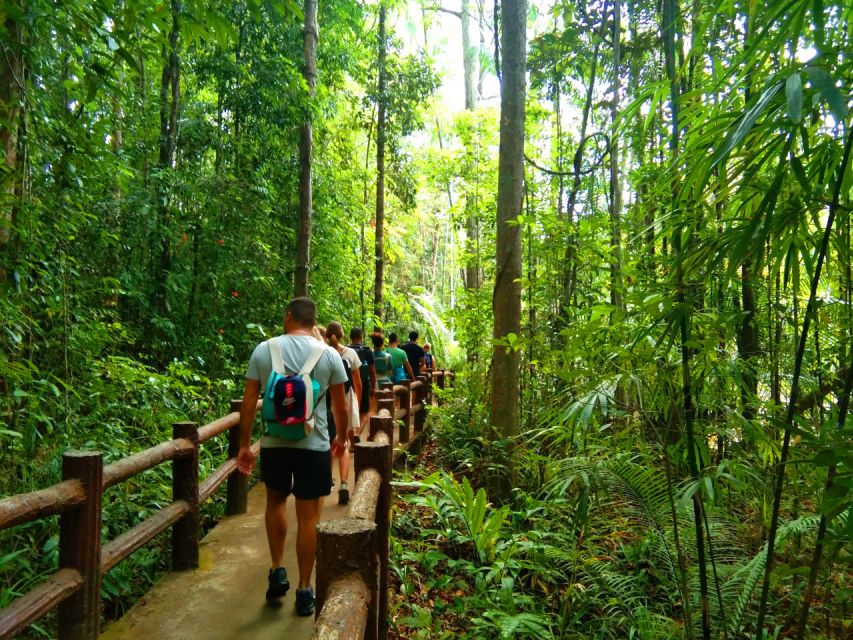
[172,422,201,571]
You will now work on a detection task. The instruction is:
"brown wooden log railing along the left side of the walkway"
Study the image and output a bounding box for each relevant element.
[0,400,260,640]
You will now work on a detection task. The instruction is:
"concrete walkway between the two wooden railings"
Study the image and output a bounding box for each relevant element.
[101,464,354,640]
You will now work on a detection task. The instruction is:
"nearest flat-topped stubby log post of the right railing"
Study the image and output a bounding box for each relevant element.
[315,518,379,640]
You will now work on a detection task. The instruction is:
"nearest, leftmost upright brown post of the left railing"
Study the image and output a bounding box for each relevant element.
[59,451,104,640]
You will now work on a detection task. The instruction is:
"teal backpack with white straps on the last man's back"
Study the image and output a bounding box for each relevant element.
[261,338,326,440]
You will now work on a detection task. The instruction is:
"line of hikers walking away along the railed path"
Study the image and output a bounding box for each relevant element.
[237,297,436,616]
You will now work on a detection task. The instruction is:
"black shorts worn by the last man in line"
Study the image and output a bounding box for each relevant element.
[261,447,332,500]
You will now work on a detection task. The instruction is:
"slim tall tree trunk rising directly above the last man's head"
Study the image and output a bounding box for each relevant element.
[293,0,319,296]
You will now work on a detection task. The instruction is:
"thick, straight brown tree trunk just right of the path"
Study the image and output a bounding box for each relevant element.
[491,0,527,500]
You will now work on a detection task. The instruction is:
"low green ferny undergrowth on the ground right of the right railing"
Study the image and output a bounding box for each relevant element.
[392,382,851,640]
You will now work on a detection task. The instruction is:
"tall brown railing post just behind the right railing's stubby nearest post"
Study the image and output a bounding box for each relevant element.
[355,442,392,640]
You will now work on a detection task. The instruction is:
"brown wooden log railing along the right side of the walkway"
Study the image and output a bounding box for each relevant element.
[312,370,455,640]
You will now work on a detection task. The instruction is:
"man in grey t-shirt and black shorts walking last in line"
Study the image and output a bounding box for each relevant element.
[237,298,347,616]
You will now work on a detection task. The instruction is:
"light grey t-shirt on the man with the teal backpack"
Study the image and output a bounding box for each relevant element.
[246,335,347,451]
